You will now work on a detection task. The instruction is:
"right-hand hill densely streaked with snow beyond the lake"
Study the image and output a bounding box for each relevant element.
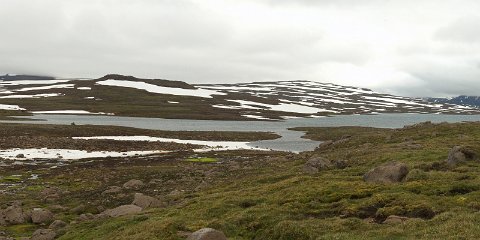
[197,81,479,116]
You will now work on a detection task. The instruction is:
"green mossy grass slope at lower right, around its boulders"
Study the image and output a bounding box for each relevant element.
[47,123,480,239]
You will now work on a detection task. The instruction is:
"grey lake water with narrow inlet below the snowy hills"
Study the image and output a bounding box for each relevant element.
[2,114,480,152]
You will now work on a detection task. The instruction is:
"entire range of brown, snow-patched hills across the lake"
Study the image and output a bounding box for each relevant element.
[0,75,480,120]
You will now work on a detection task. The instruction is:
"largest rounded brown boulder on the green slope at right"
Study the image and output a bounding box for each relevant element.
[363,162,408,183]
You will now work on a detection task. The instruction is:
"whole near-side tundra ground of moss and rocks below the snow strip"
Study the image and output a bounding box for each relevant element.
[0,123,480,239]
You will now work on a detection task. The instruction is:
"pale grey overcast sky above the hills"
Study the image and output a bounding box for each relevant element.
[0,0,480,96]
